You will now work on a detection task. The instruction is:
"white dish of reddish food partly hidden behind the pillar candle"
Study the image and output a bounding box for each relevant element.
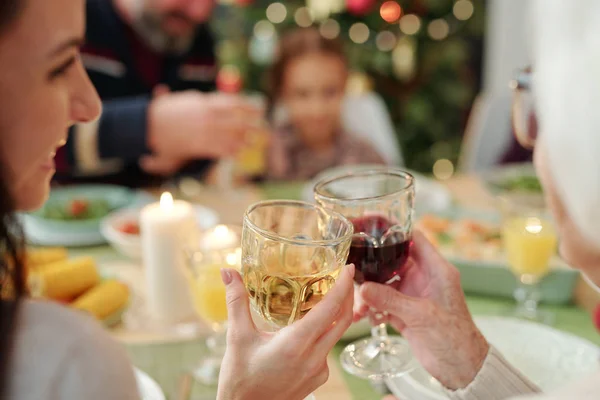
[100,205,219,260]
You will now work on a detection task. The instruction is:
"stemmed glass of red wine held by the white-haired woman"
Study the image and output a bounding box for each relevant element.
[314,168,417,380]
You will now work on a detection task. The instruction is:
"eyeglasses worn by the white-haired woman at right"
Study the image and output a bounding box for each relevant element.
[509,67,538,150]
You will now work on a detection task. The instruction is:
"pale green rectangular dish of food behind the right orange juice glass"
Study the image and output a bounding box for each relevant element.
[415,209,579,304]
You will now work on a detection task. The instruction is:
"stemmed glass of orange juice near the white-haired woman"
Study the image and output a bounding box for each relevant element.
[502,201,558,323]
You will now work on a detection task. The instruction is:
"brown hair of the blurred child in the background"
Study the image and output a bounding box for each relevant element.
[268,28,347,102]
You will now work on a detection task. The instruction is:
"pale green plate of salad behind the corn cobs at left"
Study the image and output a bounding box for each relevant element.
[21,185,136,247]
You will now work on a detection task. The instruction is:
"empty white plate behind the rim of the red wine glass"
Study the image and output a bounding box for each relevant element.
[302,164,452,213]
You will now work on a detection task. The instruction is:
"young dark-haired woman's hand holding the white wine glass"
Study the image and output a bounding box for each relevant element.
[217,266,354,400]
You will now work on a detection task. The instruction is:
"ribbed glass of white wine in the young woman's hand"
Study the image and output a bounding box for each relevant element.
[242,200,353,396]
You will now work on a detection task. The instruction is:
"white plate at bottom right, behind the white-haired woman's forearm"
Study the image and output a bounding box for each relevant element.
[387,317,600,400]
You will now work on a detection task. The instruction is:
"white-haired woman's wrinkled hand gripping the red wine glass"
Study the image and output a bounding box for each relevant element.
[355,232,489,389]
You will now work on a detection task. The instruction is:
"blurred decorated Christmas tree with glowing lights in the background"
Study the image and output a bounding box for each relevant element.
[213,0,485,172]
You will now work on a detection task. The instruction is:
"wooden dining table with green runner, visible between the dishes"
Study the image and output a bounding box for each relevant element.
[73,174,600,400]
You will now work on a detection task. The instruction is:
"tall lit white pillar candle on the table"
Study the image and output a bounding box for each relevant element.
[140,193,197,323]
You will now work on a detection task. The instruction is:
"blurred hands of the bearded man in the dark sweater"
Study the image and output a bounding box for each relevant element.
[145,87,264,175]
